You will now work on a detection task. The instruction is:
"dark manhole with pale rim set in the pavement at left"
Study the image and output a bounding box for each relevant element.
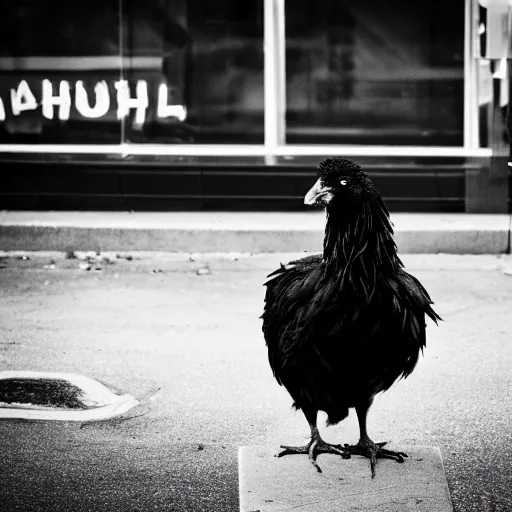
[0,371,139,421]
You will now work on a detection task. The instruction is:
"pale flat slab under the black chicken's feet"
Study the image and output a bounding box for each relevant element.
[239,445,453,512]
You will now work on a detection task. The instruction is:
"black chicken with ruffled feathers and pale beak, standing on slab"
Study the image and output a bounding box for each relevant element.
[262,158,441,478]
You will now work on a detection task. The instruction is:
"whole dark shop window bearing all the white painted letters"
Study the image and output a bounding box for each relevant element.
[0,0,263,144]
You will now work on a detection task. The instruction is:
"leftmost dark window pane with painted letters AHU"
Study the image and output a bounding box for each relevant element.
[0,0,122,144]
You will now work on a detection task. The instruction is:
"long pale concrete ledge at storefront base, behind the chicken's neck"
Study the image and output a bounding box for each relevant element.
[0,211,510,254]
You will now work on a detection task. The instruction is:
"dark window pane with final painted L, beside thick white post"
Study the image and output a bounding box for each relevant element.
[123,0,264,144]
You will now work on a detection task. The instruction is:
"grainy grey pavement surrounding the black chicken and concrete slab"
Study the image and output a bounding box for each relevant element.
[0,254,512,512]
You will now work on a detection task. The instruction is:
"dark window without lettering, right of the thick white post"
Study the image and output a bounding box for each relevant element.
[286,0,464,146]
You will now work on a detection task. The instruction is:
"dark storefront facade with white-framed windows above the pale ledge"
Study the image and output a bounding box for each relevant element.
[0,0,509,213]
